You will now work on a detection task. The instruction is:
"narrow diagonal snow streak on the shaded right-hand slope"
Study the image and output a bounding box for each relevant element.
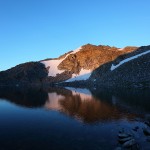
[110,50,150,71]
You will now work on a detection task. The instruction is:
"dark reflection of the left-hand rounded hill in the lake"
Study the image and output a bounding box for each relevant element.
[0,87,48,108]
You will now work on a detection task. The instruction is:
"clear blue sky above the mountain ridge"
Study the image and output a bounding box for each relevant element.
[0,0,150,70]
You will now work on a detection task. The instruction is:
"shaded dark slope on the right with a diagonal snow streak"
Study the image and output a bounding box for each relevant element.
[91,46,150,88]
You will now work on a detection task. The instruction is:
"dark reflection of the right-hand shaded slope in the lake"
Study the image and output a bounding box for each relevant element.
[91,89,150,113]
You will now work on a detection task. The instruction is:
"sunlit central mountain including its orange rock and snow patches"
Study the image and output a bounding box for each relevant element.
[41,44,137,82]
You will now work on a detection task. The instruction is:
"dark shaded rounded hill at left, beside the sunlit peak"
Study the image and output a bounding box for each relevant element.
[0,62,48,86]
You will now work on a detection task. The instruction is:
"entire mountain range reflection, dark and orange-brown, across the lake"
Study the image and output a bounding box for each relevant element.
[0,87,150,123]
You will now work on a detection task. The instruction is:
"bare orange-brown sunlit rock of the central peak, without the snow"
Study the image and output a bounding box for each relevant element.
[58,44,136,73]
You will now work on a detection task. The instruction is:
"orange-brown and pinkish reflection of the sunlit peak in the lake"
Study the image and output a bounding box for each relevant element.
[44,88,137,123]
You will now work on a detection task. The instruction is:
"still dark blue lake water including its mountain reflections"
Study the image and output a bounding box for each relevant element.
[0,88,150,150]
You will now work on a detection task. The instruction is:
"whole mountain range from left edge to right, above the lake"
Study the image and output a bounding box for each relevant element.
[0,44,150,87]
